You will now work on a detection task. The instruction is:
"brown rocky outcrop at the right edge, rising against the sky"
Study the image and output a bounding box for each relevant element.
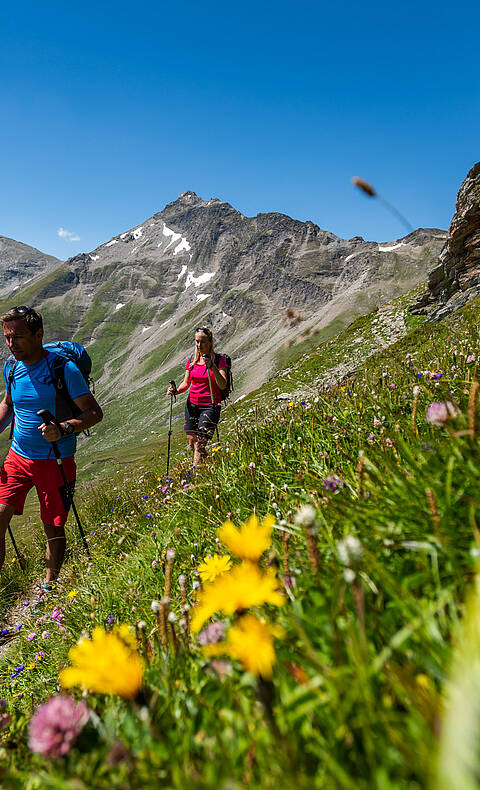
[412,162,480,321]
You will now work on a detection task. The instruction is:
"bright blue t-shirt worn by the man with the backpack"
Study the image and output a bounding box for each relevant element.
[3,351,90,460]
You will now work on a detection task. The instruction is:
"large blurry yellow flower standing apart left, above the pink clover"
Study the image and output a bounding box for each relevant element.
[60,625,143,699]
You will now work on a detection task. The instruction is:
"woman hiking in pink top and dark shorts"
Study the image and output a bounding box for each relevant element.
[167,326,227,466]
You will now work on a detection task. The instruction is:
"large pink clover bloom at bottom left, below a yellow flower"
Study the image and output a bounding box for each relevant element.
[28,696,90,758]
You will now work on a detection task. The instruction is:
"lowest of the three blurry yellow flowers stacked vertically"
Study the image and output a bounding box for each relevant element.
[204,614,285,679]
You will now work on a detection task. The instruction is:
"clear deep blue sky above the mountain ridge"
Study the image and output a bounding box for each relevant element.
[0,0,480,259]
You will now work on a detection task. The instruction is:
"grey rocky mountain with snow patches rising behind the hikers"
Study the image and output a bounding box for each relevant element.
[0,196,446,412]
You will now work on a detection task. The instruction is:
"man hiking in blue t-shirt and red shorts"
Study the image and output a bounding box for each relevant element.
[0,305,103,600]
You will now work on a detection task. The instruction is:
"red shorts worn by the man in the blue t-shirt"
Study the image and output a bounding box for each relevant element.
[0,450,77,527]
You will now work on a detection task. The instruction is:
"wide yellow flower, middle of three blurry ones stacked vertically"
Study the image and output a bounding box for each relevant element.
[191,562,284,633]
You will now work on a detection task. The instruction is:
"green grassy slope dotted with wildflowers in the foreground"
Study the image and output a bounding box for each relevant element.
[0,298,480,790]
